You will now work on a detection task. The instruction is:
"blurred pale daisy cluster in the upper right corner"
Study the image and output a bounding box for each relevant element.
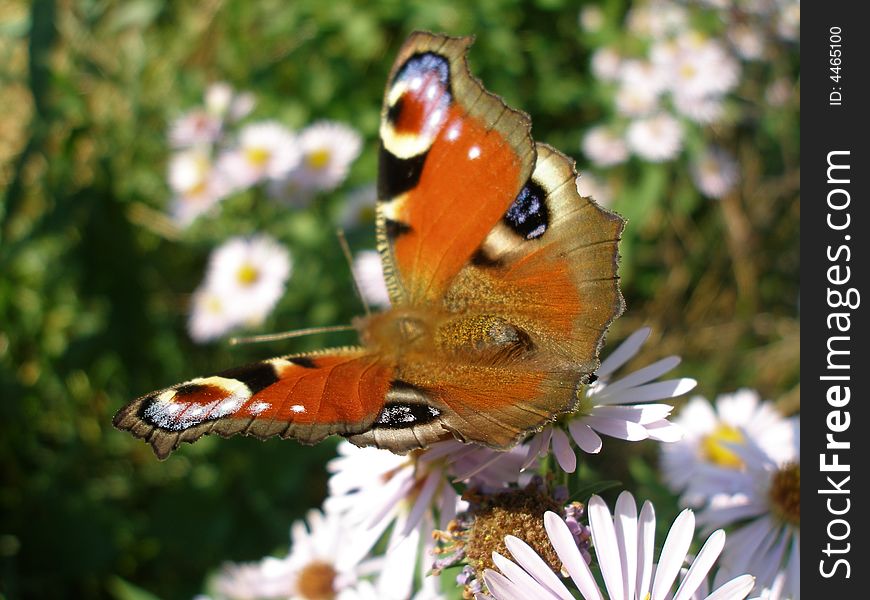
[580,0,800,204]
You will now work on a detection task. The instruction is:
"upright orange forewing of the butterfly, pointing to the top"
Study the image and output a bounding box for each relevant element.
[378,32,535,305]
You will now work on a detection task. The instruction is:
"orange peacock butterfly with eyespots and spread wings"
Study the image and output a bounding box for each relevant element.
[114,32,624,459]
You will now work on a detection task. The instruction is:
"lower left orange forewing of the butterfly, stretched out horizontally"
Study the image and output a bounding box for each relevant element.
[115,348,394,458]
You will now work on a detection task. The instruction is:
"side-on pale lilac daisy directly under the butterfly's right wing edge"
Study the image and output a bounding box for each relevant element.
[521,327,696,473]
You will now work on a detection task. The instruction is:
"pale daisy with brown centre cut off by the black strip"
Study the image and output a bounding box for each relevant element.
[693,418,800,600]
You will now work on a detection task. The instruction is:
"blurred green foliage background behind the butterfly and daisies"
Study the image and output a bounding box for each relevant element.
[0,0,800,598]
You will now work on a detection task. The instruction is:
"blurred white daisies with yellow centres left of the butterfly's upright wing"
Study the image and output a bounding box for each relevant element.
[168,83,364,342]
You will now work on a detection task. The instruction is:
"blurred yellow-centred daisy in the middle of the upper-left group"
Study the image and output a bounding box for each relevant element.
[217,121,301,189]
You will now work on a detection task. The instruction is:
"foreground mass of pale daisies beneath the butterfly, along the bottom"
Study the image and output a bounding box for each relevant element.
[194,329,800,600]
